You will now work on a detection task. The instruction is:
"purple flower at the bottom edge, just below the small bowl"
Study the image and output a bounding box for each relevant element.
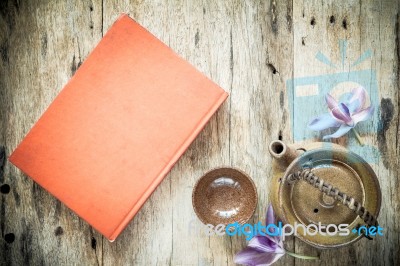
[235,205,286,266]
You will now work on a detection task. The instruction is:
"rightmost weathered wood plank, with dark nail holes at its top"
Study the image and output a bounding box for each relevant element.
[293,1,400,265]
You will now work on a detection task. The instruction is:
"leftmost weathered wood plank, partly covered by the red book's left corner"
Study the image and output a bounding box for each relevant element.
[0,1,102,265]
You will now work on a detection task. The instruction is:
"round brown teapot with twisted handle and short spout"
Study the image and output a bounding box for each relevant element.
[269,140,381,248]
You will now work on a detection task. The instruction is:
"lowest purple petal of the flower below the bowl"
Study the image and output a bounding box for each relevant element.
[234,247,285,266]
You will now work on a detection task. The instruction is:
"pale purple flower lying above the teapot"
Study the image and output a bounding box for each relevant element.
[308,87,374,141]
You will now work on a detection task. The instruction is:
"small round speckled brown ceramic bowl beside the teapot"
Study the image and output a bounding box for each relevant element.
[192,168,257,225]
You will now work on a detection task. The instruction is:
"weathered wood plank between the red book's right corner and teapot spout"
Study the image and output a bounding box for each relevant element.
[230,1,293,265]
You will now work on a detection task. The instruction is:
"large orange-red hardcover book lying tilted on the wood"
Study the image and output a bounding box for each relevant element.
[10,15,227,241]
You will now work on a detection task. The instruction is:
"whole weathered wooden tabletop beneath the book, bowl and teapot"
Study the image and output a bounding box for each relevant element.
[0,0,400,265]
